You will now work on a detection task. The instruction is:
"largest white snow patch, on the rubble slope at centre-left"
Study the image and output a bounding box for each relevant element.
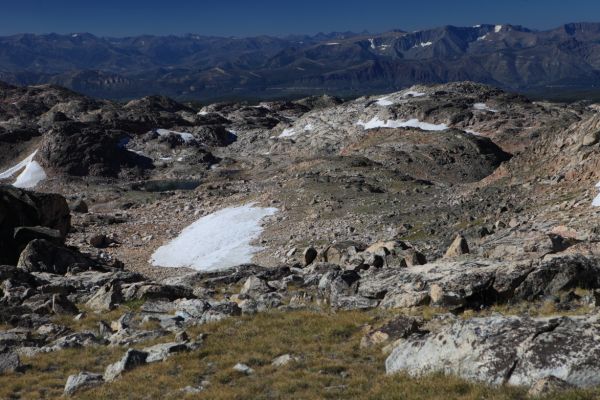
[150,203,278,271]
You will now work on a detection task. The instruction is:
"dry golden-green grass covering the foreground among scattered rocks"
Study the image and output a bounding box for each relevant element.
[0,310,600,400]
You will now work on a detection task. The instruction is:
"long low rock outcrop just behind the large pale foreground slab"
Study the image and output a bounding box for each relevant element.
[328,256,600,309]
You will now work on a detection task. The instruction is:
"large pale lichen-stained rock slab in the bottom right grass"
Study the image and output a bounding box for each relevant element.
[385,316,600,387]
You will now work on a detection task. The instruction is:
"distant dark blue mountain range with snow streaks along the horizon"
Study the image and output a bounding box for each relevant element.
[0,23,600,100]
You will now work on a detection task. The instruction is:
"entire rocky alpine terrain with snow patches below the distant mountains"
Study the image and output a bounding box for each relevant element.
[0,82,600,399]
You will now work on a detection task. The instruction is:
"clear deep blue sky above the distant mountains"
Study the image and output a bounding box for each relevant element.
[0,0,600,36]
